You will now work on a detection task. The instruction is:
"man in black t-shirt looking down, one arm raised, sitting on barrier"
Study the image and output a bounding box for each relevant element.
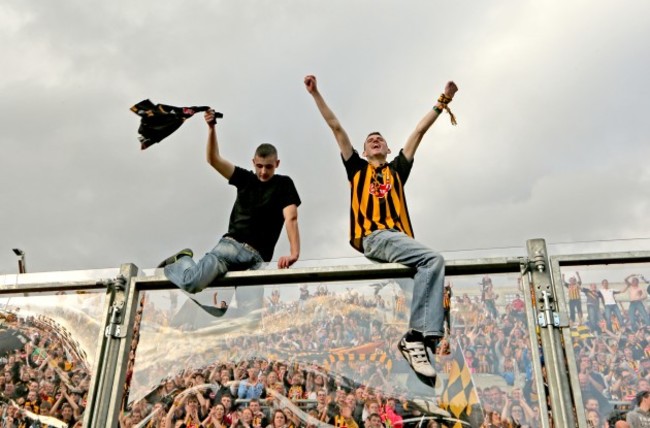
[158,110,300,302]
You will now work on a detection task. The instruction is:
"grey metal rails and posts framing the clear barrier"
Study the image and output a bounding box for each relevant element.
[0,239,650,428]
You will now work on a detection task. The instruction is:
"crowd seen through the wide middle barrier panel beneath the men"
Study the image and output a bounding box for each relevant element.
[117,278,539,428]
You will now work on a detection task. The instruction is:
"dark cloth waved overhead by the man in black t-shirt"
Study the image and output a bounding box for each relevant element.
[131,100,223,150]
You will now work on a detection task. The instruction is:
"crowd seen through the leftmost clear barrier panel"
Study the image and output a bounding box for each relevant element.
[0,310,91,428]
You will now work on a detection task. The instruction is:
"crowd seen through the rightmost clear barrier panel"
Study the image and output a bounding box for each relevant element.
[563,272,650,427]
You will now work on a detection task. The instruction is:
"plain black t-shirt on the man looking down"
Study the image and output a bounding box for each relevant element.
[225,166,300,262]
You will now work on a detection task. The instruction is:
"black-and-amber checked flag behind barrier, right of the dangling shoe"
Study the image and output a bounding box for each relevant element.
[440,341,483,428]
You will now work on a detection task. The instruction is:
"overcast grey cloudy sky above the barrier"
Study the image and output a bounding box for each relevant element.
[0,0,650,273]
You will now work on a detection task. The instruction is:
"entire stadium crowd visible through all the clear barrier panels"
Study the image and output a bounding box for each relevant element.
[0,273,650,428]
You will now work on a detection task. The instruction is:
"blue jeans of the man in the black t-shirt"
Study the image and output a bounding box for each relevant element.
[165,237,264,294]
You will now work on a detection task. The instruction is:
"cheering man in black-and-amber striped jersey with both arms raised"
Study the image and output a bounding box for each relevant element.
[304,76,458,382]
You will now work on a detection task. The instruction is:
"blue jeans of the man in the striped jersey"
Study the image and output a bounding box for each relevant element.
[363,229,445,337]
